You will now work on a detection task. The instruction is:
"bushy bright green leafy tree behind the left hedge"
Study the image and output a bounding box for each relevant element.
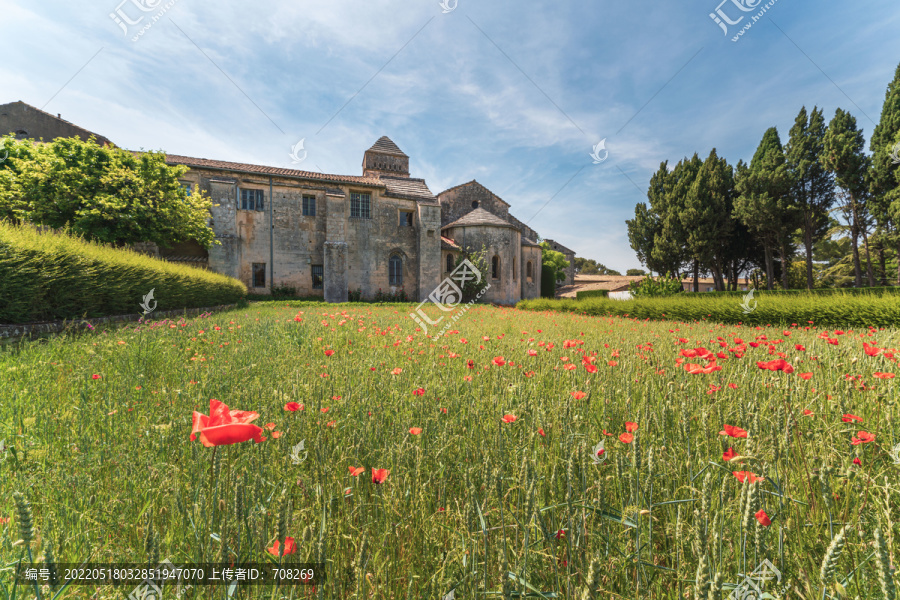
[0,137,218,248]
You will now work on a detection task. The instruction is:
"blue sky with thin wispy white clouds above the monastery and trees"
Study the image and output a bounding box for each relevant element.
[0,0,900,271]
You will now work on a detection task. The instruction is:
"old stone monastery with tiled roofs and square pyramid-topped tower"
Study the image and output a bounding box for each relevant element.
[0,102,574,304]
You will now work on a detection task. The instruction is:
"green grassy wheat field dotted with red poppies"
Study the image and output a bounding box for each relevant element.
[0,303,900,600]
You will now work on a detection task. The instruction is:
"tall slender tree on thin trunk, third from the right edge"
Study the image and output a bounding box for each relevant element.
[785,106,834,289]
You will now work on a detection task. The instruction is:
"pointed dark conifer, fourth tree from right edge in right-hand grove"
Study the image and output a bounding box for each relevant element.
[734,127,798,290]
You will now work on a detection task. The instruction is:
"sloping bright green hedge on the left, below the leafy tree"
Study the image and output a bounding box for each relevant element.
[0,222,247,323]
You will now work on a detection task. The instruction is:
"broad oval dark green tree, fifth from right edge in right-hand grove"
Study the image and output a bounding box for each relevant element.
[680,148,734,291]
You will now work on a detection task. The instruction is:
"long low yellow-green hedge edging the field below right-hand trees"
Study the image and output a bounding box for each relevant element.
[516,294,900,328]
